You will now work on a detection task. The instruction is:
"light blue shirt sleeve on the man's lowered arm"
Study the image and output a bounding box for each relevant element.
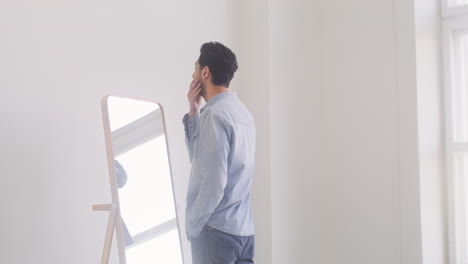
[186,113,230,237]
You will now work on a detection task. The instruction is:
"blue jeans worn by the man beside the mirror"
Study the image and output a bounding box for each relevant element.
[190,226,255,264]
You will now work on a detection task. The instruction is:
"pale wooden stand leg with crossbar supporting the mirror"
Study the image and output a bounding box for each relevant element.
[92,204,125,264]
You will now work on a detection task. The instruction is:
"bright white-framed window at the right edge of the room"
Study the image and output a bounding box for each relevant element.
[442,5,468,264]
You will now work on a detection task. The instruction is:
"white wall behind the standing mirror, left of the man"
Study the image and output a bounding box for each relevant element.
[0,0,232,264]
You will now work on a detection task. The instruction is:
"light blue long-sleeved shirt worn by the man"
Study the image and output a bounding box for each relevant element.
[183,92,255,240]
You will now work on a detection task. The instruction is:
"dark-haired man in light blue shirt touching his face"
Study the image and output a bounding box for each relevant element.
[183,42,255,264]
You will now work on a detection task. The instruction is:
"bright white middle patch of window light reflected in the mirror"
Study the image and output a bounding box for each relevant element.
[117,136,176,235]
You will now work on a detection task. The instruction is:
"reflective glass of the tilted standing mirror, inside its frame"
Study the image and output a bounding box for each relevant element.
[103,96,182,264]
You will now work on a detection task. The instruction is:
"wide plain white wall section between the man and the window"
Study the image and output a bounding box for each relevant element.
[268,0,422,264]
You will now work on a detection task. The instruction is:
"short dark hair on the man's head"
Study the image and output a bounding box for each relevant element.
[198,42,237,87]
